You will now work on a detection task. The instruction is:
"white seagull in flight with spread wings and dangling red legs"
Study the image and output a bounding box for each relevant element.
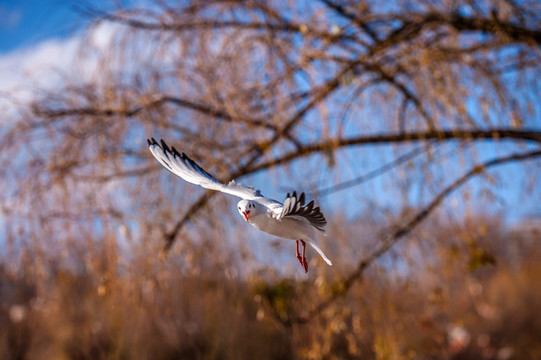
[147,138,332,273]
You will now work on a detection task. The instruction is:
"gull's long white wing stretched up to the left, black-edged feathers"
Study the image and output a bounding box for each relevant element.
[147,138,280,207]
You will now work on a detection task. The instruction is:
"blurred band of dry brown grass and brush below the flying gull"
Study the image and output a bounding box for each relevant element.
[0,215,541,359]
